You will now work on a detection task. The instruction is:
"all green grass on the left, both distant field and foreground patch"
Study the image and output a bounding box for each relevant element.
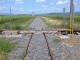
[0,16,35,60]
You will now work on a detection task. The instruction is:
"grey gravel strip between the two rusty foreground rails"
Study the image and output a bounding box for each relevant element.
[25,34,51,60]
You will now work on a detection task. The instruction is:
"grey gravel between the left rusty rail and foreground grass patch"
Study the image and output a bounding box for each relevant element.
[8,34,31,60]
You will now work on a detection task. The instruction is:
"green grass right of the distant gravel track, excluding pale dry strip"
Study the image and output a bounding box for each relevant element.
[43,15,80,29]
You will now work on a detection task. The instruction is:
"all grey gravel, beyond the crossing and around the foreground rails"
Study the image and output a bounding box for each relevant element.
[8,17,80,60]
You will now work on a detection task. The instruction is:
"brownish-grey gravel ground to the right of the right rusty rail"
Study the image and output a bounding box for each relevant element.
[47,34,80,60]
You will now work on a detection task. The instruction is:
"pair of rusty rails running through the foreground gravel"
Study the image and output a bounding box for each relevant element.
[23,32,54,60]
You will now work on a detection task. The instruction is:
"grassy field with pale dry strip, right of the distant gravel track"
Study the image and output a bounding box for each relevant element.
[43,15,80,30]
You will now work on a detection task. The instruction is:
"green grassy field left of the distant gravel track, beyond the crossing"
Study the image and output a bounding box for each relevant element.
[0,16,35,30]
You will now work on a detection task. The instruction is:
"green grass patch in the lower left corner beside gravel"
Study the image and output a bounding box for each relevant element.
[0,39,15,60]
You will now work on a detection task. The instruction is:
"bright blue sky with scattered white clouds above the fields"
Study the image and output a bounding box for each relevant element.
[0,0,80,14]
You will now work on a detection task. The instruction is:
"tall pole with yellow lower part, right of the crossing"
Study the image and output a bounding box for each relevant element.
[70,0,74,37]
